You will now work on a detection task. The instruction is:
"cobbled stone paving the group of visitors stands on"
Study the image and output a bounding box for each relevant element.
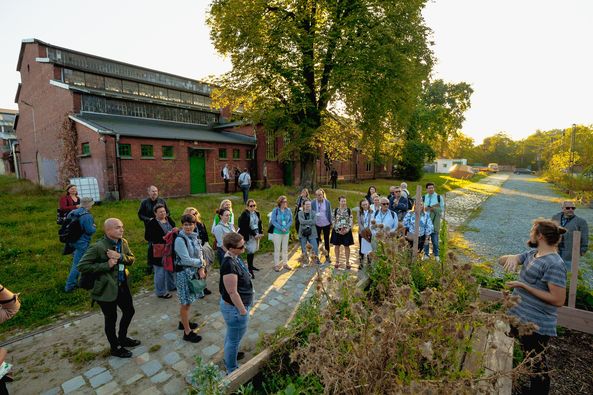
[7,244,358,395]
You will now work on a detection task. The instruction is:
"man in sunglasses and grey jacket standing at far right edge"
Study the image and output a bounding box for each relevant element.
[552,200,589,270]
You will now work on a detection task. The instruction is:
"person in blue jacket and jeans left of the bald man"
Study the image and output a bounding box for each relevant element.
[64,196,97,292]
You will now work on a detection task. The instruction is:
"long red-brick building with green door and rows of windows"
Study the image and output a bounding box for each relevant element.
[15,39,375,199]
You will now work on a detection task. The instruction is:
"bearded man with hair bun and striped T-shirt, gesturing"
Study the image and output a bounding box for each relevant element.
[498,219,566,395]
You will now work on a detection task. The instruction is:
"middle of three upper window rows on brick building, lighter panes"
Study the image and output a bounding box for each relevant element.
[63,69,212,108]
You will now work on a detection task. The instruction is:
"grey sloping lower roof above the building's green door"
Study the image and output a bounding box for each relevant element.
[70,112,256,145]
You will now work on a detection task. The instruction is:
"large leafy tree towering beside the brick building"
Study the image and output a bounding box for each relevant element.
[208,0,433,186]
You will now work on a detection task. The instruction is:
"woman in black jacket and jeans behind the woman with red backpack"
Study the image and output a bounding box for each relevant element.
[144,203,175,299]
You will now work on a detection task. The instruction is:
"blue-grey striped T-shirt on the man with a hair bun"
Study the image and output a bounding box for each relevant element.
[509,249,566,336]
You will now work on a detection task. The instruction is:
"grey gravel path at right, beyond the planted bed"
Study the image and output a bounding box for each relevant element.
[462,174,593,280]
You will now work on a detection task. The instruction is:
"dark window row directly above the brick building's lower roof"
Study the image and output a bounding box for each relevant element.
[82,95,218,125]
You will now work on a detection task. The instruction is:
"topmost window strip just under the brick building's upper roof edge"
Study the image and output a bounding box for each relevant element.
[47,48,212,95]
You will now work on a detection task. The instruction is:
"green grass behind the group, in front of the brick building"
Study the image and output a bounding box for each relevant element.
[0,175,475,338]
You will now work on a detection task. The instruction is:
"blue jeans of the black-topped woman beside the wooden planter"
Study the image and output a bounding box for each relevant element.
[220,298,251,374]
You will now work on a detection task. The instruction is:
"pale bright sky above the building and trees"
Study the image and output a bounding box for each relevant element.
[0,0,593,142]
